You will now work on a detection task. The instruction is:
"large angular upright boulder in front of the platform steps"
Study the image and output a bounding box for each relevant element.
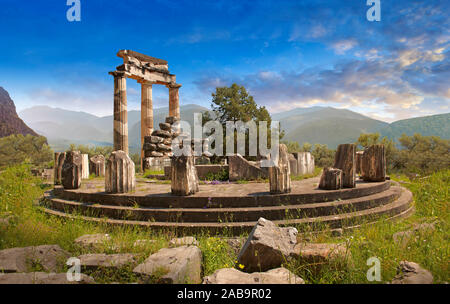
[238,218,298,272]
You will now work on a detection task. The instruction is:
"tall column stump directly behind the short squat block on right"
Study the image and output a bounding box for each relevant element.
[333,144,356,188]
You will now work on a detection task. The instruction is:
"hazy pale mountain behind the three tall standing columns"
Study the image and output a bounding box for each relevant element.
[19,105,208,152]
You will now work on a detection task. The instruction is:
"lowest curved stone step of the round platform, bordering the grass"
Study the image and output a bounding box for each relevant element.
[42,188,414,235]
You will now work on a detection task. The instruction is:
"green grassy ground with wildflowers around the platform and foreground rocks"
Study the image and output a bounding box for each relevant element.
[0,166,450,283]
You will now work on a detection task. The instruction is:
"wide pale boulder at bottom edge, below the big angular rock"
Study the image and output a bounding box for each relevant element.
[203,267,305,284]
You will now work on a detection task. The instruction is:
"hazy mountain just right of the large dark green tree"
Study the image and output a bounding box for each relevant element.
[272,107,389,149]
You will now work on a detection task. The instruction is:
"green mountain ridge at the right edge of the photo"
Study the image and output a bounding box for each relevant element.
[381,113,450,139]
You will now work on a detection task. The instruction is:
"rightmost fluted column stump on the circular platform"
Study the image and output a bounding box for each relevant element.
[361,145,386,182]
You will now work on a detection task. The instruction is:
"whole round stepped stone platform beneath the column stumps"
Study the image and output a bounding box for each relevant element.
[40,178,412,234]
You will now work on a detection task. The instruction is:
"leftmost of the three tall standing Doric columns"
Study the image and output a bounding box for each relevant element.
[110,72,128,154]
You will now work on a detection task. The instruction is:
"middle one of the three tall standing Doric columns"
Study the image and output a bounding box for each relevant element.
[140,81,153,160]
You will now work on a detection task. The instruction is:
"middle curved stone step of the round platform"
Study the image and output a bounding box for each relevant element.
[45,187,401,223]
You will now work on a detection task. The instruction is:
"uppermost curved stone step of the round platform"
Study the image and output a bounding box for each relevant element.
[54,181,391,208]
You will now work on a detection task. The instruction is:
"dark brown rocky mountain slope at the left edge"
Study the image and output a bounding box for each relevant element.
[0,87,38,137]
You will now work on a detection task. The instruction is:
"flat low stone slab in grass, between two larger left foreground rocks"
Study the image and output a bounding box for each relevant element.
[78,253,136,269]
